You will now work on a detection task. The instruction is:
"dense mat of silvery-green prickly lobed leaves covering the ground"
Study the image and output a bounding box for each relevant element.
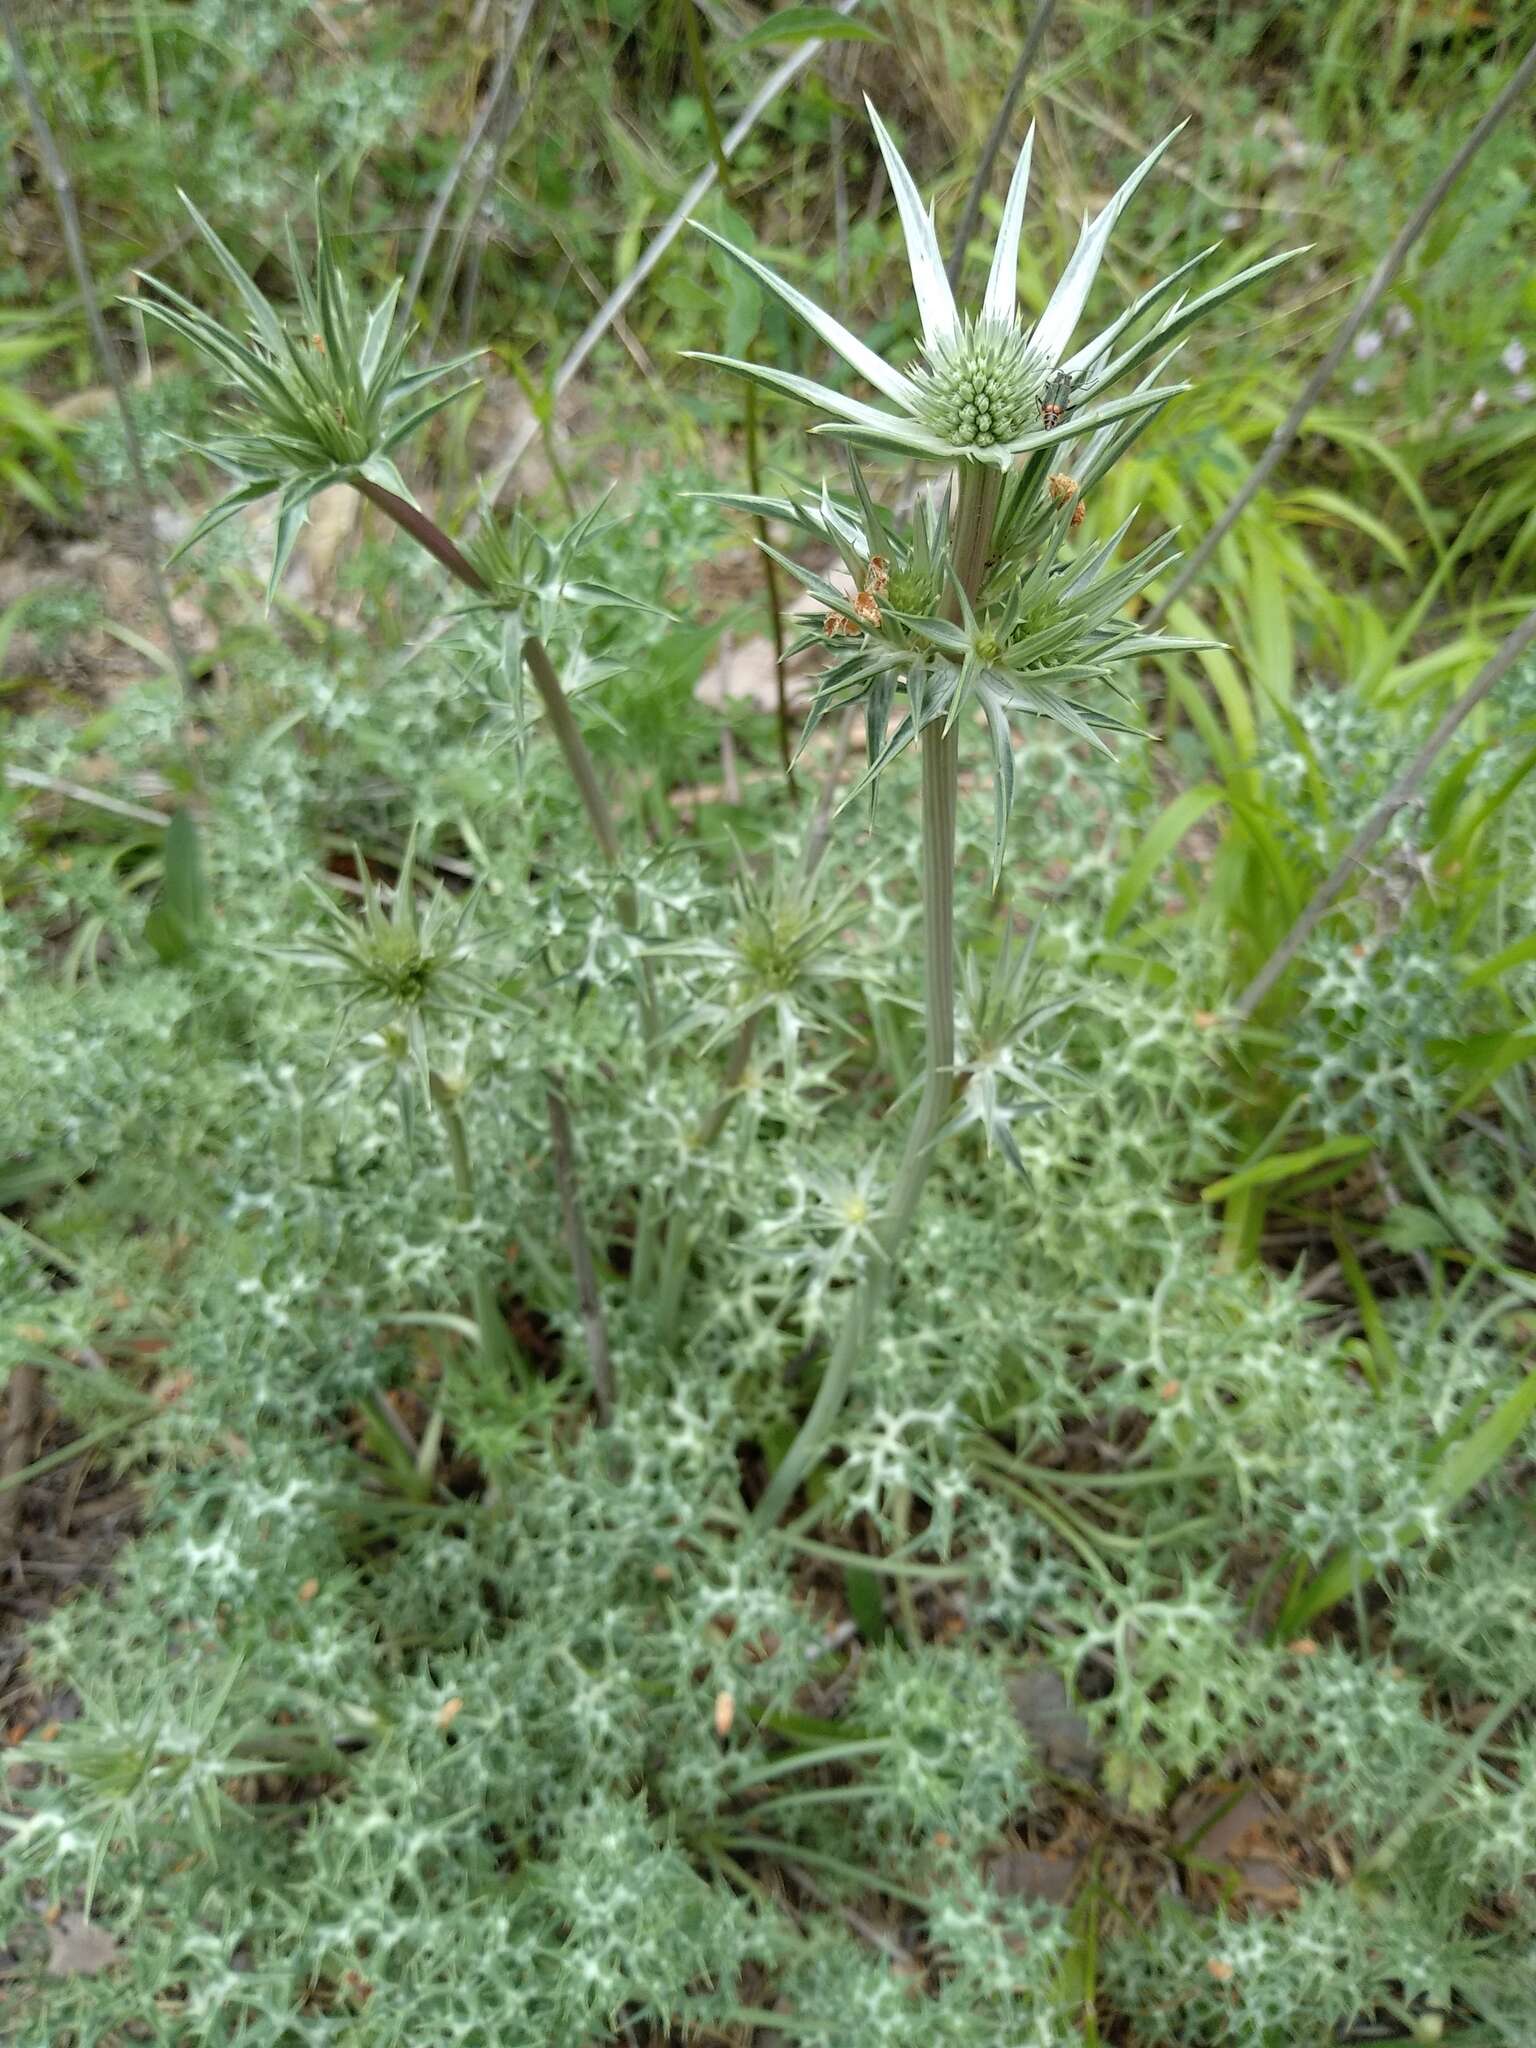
[0,344,1532,2048]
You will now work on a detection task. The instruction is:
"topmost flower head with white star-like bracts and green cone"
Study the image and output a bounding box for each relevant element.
[692,102,1294,469]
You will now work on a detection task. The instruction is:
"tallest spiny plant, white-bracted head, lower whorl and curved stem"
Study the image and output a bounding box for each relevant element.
[700,106,1296,1522]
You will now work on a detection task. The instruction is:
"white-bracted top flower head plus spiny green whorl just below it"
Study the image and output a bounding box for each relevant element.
[702,94,1296,879]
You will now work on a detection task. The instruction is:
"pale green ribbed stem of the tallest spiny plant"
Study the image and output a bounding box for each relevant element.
[756,463,1004,1526]
